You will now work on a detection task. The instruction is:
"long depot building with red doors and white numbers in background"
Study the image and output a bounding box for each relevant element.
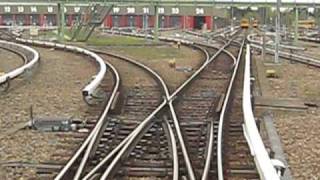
[0,3,226,29]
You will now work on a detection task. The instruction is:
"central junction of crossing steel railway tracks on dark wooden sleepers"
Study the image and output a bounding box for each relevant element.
[7,29,282,180]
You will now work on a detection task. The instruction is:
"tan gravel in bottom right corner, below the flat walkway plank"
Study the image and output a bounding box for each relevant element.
[274,110,320,180]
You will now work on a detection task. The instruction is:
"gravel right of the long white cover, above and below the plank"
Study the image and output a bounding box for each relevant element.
[254,50,320,180]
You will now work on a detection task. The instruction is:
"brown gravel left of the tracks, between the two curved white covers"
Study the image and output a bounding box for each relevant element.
[0,48,96,179]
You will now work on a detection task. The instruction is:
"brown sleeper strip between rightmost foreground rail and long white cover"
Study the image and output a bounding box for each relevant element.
[218,37,259,179]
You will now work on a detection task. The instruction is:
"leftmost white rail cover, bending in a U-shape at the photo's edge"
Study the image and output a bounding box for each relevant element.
[0,40,40,84]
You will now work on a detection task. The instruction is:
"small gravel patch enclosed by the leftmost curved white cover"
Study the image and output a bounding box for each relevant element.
[0,48,23,73]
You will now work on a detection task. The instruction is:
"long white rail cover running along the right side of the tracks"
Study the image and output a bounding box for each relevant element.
[242,45,280,180]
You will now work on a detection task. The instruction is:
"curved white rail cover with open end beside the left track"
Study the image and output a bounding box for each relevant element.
[16,38,107,97]
